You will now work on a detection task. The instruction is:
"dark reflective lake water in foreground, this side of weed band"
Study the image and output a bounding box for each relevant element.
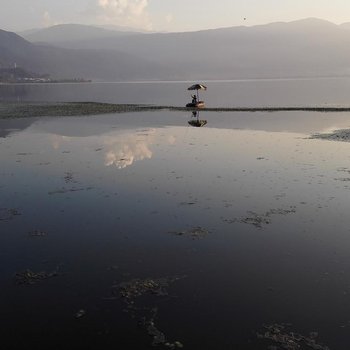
[0,105,350,350]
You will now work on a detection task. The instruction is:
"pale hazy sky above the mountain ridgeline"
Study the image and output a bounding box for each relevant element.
[0,0,350,31]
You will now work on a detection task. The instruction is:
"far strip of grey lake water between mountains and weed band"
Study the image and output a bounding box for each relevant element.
[0,78,350,107]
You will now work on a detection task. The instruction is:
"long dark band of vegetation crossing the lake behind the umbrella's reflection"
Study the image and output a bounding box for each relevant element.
[0,102,350,119]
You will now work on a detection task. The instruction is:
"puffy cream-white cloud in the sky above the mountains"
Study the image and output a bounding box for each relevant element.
[97,0,152,30]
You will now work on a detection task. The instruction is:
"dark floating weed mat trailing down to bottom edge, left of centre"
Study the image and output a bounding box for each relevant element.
[108,276,186,349]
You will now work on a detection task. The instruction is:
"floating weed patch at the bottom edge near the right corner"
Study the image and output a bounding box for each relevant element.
[256,324,329,350]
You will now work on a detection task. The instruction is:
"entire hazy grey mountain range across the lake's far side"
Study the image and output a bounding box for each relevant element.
[0,18,350,80]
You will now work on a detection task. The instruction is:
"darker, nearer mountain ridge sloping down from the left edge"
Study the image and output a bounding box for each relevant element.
[0,30,174,80]
